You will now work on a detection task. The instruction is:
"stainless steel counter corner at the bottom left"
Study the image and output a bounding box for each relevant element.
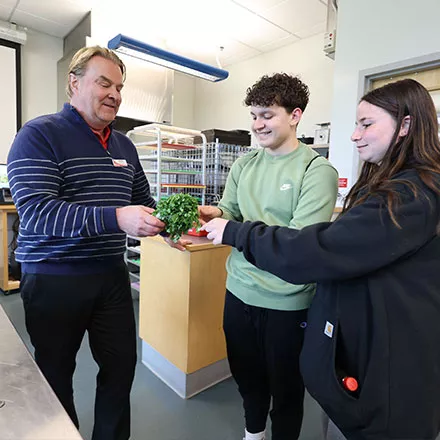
[0,306,82,440]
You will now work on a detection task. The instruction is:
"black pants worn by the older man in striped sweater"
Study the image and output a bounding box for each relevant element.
[20,264,136,440]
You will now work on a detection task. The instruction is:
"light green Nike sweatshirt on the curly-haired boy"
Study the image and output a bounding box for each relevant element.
[218,143,338,310]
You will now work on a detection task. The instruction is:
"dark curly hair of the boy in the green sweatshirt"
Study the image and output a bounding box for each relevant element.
[244,73,310,113]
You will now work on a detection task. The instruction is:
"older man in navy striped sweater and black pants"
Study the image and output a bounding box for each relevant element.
[8,46,164,440]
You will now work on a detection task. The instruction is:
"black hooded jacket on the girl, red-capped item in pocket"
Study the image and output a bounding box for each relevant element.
[223,171,440,440]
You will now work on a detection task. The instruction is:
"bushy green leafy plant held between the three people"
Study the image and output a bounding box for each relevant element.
[153,193,200,242]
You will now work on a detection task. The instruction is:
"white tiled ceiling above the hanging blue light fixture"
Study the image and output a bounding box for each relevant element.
[0,0,327,66]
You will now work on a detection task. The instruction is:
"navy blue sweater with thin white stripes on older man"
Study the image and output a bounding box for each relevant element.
[8,104,155,274]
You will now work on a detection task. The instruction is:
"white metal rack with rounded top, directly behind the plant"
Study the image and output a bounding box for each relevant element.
[127,124,206,204]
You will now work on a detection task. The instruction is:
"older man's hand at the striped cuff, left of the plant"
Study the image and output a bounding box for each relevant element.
[116,205,165,237]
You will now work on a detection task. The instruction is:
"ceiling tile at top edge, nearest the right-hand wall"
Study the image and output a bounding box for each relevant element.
[262,0,327,34]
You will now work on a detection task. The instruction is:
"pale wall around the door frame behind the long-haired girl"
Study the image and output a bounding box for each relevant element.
[330,0,440,196]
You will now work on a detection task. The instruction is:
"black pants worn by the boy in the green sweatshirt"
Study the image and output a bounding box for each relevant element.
[223,291,307,440]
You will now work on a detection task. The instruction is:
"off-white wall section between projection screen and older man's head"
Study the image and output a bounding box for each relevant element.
[21,29,63,123]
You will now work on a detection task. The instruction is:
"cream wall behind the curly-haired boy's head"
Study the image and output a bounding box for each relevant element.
[195,34,334,136]
